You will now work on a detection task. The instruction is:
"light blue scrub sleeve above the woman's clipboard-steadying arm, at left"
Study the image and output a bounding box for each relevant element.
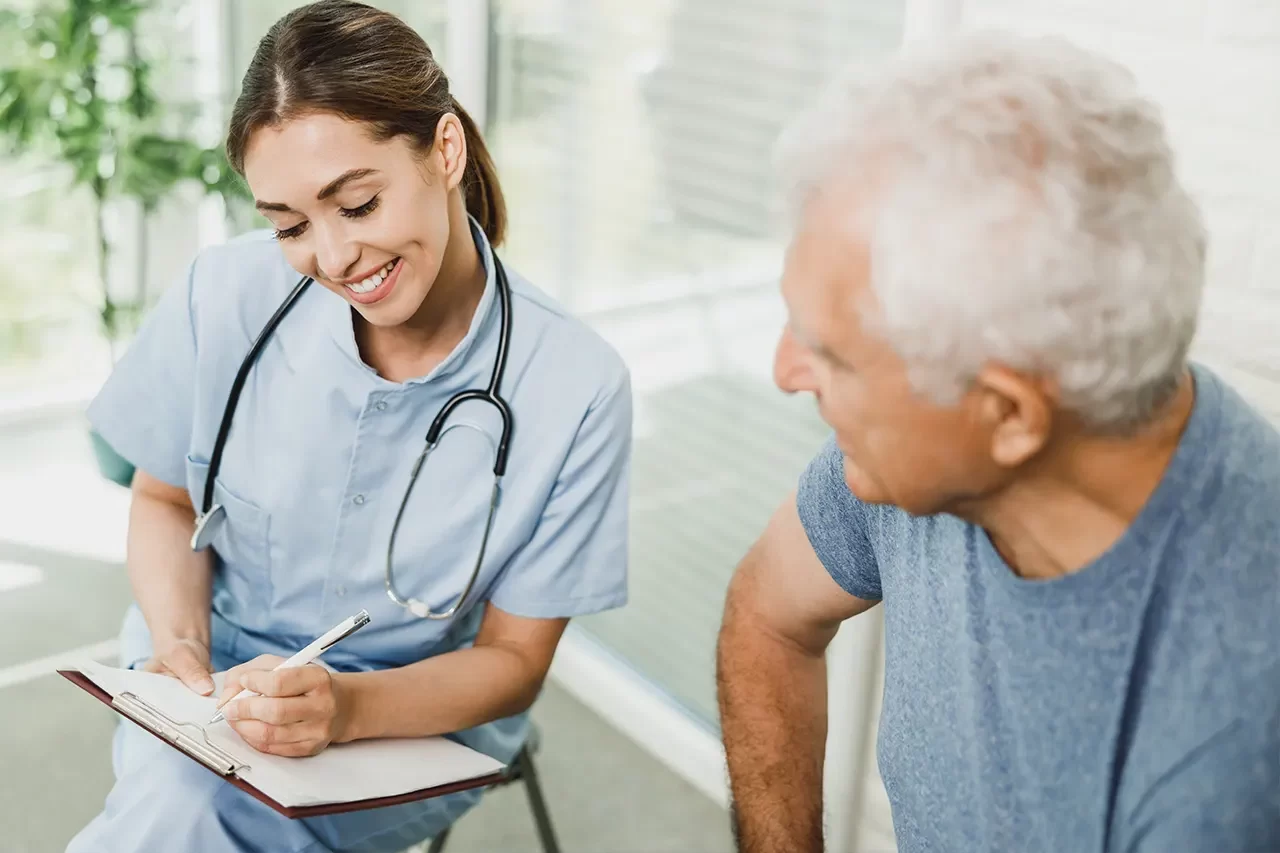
[87,252,196,487]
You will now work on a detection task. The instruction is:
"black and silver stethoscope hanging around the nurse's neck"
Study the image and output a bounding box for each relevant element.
[191,255,513,620]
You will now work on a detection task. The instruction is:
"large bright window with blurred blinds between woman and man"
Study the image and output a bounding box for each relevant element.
[489,0,902,725]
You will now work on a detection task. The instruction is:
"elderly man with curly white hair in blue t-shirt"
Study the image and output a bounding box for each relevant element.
[718,28,1280,853]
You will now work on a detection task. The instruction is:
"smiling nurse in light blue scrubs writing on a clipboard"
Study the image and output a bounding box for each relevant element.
[69,0,631,853]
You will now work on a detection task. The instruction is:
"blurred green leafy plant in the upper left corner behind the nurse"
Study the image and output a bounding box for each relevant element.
[0,0,248,351]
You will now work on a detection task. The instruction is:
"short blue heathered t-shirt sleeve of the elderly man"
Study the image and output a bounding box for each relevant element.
[796,439,881,601]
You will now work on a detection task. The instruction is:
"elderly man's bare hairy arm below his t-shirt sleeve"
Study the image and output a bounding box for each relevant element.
[717,496,876,853]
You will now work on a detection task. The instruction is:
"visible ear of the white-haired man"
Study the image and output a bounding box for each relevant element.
[975,365,1056,467]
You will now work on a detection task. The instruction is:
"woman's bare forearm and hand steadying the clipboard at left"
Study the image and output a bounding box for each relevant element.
[127,470,214,694]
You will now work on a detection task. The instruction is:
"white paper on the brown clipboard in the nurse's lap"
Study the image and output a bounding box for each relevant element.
[76,662,503,807]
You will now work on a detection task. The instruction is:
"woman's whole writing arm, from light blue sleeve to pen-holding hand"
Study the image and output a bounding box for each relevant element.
[221,366,631,756]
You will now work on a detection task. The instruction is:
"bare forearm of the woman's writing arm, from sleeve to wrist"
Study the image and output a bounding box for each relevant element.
[334,603,568,743]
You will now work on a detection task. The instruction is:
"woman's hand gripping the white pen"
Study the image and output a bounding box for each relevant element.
[218,654,348,757]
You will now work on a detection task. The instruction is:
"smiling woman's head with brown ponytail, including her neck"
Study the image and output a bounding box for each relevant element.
[227,1,506,375]
